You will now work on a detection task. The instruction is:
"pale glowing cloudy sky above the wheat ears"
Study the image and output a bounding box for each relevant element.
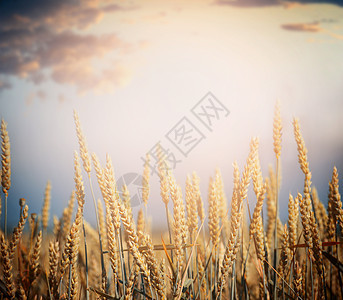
[0,0,343,230]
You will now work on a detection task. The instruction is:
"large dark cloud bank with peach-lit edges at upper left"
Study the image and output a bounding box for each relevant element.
[0,0,141,94]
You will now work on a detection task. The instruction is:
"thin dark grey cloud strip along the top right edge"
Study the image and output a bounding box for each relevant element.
[216,0,343,7]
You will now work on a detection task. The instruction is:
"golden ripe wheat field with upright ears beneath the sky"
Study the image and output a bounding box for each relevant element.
[0,104,343,300]
